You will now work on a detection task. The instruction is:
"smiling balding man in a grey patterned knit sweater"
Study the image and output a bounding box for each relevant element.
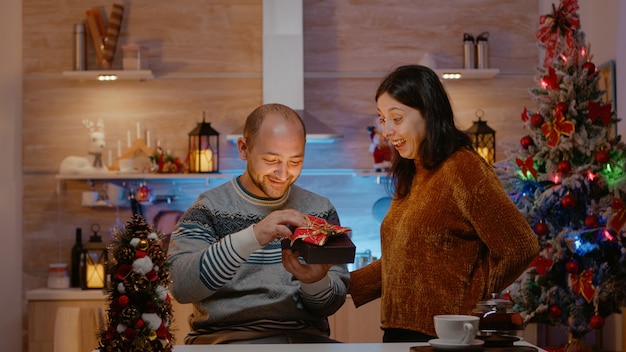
[168,104,349,344]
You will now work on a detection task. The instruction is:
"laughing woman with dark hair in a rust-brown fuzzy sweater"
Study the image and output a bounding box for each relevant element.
[350,65,539,342]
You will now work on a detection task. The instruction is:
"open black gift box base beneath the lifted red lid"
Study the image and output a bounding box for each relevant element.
[282,233,356,264]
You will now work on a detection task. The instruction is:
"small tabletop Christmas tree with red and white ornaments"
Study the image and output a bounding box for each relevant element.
[98,214,174,352]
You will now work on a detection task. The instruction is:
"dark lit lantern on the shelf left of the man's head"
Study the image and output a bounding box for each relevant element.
[188,112,220,173]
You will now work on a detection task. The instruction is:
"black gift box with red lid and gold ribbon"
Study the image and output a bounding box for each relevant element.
[282,215,356,264]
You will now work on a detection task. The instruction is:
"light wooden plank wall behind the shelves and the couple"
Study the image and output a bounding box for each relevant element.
[22,0,538,350]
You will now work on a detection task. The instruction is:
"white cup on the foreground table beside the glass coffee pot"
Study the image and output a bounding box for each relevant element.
[434,315,480,345]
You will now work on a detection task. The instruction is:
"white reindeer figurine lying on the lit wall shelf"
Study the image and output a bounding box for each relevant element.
[59,119,108,174]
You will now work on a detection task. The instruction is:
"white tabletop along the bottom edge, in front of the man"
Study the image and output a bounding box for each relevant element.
[168,341,545,352]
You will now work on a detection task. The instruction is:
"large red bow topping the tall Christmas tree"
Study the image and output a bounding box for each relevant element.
[535,0,580,67]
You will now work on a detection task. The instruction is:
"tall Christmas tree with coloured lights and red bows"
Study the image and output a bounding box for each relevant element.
[496,0,626,337]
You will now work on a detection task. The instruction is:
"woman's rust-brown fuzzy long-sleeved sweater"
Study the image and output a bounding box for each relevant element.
[350,149,539,336]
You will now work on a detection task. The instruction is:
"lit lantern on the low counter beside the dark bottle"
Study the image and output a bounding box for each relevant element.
[80,224,108,290]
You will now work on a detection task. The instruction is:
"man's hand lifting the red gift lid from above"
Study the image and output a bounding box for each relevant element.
[254,209,306,246]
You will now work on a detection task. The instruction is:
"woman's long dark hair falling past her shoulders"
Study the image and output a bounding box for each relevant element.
[376,65,473,199]
